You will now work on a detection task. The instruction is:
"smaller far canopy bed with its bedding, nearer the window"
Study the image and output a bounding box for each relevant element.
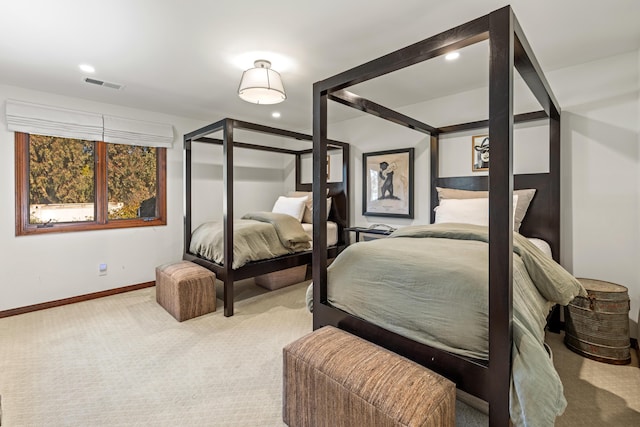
[183,118,349,316]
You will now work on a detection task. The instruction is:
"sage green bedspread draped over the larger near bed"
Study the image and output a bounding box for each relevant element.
[307,224,586,426]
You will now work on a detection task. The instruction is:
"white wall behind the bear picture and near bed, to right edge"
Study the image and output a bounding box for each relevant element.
[329,52,640,337]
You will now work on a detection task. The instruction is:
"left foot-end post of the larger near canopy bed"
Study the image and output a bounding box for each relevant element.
[311,83,328,329]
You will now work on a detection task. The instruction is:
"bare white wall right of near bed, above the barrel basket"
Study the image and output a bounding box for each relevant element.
[549,52,640,337]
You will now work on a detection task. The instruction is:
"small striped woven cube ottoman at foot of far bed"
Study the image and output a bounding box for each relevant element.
[156,261,216,322]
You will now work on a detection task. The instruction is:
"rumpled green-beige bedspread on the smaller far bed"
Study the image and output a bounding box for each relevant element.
[189,212,311,269]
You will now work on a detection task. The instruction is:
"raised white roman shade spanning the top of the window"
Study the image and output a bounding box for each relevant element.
[6,99,174,148]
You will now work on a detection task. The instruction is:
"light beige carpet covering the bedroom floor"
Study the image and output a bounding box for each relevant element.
[0,281,640,427]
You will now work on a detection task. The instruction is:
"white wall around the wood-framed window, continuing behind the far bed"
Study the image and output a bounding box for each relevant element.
[0,85,284,311]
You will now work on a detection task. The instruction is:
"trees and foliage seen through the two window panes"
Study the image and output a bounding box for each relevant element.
[29,135,157,224]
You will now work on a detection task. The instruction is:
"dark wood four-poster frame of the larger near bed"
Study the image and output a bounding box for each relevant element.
[312,6,560,426]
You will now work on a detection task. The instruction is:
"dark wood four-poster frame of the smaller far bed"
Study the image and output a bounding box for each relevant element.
[183,118,349,316]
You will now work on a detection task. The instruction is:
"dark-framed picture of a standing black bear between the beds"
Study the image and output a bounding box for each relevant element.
[362,148,414,218]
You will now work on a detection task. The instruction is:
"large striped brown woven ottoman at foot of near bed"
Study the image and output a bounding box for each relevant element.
[282,326,456,427]
